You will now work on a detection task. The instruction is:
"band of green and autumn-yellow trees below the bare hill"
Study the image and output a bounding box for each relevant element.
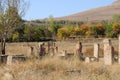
[2,15,120,42]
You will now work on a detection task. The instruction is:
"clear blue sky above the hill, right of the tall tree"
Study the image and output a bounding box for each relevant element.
[23,0,115,20]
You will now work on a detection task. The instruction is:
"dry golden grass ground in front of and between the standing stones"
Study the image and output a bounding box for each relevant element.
[0,39,120,80]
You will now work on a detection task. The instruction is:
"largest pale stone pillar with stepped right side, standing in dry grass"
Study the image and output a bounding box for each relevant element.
[103,39,113,65]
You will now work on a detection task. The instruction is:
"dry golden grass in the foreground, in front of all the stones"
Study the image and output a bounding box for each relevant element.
[0,56,120,80]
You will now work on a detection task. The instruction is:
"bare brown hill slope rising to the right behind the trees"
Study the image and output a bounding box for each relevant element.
[57,0,120,21]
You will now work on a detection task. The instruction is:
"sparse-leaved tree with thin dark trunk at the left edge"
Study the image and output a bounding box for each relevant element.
[0,0,27,55]
